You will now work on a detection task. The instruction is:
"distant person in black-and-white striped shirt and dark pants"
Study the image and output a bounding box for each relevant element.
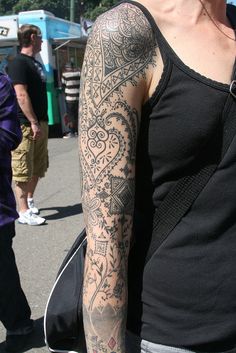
[61,63,80,138]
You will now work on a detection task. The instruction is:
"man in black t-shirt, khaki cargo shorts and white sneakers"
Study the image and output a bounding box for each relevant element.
[8,24,48,225]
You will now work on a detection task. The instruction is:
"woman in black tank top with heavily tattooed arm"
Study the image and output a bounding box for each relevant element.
[79,0,236,353]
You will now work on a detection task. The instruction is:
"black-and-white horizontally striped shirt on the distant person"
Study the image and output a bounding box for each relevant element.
[61,71,80,102]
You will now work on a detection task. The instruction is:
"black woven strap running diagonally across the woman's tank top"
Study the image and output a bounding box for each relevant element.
[146,88,236,263]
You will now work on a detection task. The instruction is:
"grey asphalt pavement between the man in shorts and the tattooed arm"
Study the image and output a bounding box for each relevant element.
[0,138,83,353]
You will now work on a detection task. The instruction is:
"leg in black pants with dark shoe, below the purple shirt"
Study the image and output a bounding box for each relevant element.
[0,223,33,353]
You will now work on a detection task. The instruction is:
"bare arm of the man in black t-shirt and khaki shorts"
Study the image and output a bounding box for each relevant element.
[14,84,41,138]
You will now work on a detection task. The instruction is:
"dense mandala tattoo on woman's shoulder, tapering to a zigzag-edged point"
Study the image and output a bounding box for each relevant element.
[81,5,156,106]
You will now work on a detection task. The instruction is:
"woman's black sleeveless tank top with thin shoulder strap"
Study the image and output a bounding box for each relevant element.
[127,1,236,352]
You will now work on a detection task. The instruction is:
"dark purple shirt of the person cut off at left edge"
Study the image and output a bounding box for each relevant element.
[0,73,22,226]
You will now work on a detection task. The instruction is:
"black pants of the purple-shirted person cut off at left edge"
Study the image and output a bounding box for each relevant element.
[0,223,31,331]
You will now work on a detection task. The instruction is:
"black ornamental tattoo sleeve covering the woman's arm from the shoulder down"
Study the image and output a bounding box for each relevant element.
[79,4,159,353]
